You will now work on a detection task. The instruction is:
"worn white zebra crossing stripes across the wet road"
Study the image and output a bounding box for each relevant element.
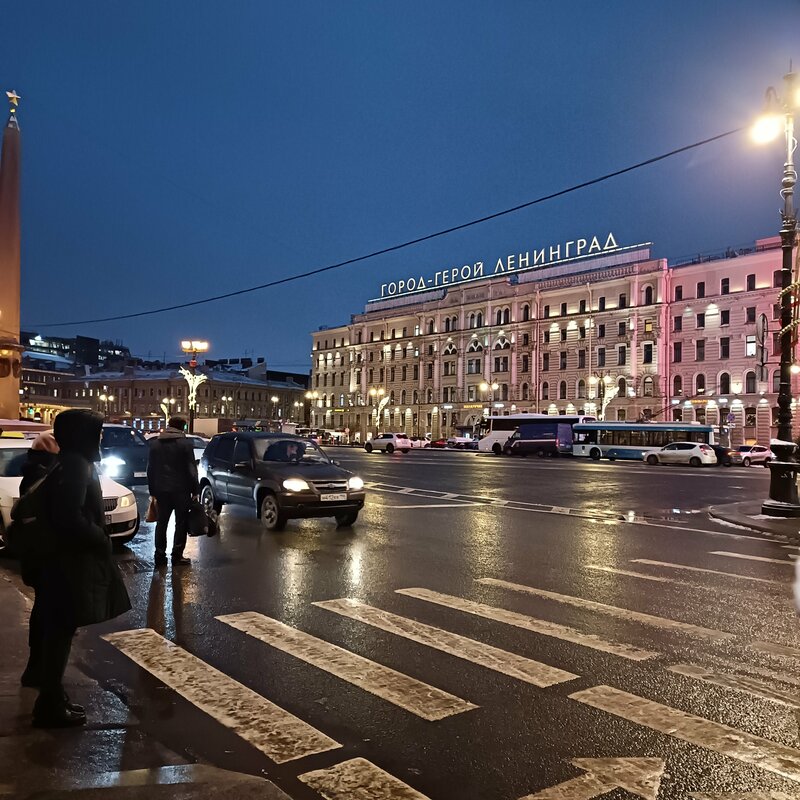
[103,551,800,800]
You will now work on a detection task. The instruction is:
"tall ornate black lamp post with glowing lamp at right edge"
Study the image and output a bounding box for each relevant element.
[753,72,800,517]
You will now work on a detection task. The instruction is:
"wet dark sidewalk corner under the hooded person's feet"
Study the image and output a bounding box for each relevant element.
[0,566,289,800]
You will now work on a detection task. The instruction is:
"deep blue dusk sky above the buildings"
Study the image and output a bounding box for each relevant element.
[6,0,800,371]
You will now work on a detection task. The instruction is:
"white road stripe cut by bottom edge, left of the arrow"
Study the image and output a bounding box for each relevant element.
[298,758,430,800]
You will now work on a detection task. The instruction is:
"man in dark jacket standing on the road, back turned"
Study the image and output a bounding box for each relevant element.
[147,417,200,564]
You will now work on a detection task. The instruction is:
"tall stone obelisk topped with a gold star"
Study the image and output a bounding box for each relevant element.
[0,90,22,420]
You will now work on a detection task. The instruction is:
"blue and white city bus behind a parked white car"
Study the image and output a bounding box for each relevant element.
[572,422,715,461]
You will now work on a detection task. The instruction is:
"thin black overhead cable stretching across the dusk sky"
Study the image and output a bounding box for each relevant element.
[29,128,743,328]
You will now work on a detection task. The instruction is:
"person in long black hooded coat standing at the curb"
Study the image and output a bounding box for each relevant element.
[28,409,131,728]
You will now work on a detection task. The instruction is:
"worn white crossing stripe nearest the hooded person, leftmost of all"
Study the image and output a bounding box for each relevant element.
[103,628,342,764]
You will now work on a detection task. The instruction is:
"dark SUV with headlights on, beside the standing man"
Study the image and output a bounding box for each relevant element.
[200,431,365,531]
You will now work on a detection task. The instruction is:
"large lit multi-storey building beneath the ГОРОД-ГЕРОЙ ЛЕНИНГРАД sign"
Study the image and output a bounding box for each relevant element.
[311,237,798,444]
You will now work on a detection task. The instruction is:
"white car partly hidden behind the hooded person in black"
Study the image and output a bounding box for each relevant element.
[0,438,139,550]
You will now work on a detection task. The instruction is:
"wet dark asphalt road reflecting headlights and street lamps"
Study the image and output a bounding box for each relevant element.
[79,448,800,800]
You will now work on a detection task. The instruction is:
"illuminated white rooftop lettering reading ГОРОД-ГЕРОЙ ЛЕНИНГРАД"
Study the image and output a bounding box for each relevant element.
[370,233,627,302]
